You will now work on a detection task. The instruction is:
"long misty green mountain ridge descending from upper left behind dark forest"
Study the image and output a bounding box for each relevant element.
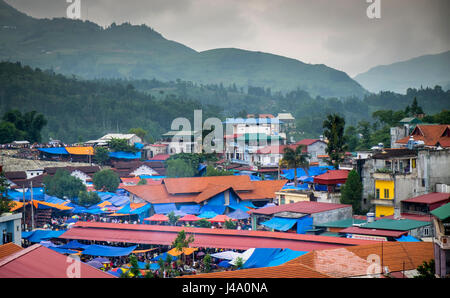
[0,0,367,97]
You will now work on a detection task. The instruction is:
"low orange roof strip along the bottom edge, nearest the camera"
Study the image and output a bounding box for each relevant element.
[180,264,331,278]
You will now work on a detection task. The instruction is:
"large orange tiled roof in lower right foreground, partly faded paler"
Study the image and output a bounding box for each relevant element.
[286,242,434,277]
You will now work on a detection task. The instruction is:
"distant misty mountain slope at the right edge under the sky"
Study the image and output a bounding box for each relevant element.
[354,51,450,94]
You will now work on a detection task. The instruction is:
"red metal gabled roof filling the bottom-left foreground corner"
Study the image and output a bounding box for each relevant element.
[0,244,114,278]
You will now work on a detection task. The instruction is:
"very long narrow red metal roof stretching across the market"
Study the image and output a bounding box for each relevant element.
[59,222,373,251]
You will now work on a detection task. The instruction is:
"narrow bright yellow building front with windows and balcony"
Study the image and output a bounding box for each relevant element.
[374,175,394,217]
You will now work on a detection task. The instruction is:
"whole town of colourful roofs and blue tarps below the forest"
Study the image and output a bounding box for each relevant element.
[0,113,450,278]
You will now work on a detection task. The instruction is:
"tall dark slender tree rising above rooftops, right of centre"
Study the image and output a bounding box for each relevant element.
[323,114,347,169]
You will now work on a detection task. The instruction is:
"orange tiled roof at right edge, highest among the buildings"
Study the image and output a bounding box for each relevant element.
[397,124,450,147]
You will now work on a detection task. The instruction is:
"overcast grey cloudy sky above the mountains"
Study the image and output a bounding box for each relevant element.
[6,0,450,77]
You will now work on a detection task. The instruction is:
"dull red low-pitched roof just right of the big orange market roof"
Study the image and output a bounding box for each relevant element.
[251,201,351,215]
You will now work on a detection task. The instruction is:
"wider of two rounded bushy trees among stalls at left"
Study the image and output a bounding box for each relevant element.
[43,170,86,199]
